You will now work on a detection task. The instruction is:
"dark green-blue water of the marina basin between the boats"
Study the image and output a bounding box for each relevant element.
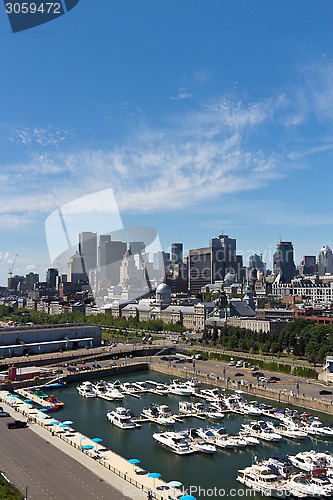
[49,372,333,499]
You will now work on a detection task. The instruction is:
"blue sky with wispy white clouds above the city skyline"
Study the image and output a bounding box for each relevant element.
[0,0,333,285]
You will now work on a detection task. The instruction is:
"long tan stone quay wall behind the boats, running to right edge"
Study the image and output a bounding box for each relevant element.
[148,363,333,416]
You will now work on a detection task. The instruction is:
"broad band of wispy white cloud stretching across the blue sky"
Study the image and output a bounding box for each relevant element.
[0,61,333,226]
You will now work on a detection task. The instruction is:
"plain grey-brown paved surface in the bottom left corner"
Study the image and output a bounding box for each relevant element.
[0,417,126,500]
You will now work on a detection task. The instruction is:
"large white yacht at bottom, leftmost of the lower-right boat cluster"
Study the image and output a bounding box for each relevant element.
[237,464,288,498]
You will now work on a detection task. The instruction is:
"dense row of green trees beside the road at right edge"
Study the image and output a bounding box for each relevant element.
[202,319,333,365]
